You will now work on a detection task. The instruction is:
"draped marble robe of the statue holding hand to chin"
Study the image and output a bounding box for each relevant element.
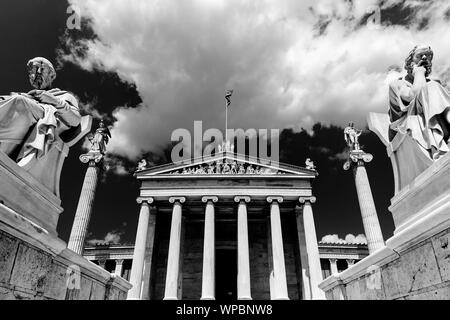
[389,78,450,159]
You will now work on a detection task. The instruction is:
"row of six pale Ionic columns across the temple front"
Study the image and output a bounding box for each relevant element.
[128,196,324,300]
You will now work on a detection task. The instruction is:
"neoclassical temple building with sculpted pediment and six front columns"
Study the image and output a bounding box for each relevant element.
[85,151,370,300]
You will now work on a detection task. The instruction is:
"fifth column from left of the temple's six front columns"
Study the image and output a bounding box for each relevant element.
[267,197,289,300]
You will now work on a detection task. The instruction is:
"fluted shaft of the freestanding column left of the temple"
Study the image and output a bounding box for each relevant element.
[67,161,100,255]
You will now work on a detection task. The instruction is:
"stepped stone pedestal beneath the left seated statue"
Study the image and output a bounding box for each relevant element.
[0,152,131,300]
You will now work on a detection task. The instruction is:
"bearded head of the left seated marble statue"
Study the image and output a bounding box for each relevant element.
[27,57,56,90]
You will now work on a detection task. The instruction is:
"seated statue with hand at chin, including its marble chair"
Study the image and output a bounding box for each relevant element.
[367,45,450,194]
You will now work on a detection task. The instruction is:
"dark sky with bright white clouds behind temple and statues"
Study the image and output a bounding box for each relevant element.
[0,0,450,242]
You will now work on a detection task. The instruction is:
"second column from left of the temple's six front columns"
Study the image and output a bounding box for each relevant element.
[164,197,186,300]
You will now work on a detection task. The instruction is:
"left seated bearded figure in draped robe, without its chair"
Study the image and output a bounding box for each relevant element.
[0,58,81,161]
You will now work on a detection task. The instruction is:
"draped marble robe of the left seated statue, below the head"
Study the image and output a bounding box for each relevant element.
[0,88,81,160]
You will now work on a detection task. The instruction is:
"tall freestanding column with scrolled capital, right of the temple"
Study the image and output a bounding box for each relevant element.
[344,150,384,253]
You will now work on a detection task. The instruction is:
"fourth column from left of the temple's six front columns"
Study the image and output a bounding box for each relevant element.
[234,197,252,300]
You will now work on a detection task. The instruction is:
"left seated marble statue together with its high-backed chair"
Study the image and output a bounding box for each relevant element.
[0,58,89,197]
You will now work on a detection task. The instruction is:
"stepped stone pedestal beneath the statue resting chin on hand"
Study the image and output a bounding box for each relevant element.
[320,154,450,300]
